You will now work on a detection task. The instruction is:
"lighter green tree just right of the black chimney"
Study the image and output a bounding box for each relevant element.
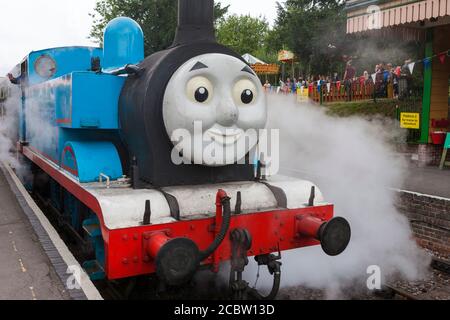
[217,14,269,55]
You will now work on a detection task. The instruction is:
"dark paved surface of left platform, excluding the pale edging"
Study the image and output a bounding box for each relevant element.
[0,166,69,300]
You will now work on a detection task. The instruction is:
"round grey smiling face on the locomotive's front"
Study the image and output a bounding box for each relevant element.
[163,54,267,166]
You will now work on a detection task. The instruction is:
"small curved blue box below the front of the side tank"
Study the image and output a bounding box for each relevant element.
[62,142,123,183]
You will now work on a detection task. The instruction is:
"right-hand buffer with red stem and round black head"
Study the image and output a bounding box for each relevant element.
[297,216,351,256]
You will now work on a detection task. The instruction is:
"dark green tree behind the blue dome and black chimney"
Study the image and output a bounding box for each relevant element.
[90,0,229,56]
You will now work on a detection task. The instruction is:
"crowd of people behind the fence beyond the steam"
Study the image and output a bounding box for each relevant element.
[264,60,412,101]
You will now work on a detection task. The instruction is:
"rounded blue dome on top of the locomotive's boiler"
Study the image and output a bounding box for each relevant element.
[102,17,144,70]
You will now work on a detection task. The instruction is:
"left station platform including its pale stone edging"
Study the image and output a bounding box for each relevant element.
[0,163,102,300]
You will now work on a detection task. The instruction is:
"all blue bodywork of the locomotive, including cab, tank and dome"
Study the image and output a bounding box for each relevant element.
[18,18,144,182]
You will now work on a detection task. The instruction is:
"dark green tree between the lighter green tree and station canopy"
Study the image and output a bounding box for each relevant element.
[268,0,349,74]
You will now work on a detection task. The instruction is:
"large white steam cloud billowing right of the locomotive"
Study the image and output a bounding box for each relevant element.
[246,95,429,298]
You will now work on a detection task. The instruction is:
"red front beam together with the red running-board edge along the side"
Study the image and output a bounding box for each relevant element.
[23,147,333,280]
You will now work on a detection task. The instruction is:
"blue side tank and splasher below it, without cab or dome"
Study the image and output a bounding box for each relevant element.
[25,72,126,182]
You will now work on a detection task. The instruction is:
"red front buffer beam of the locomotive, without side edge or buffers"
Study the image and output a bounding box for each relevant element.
[107,205,333,280]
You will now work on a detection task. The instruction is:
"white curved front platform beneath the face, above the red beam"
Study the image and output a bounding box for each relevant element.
[89,176,326,230]
